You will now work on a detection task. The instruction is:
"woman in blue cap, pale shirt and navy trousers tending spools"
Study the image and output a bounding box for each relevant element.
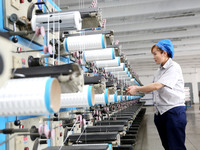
[127,39,187,150]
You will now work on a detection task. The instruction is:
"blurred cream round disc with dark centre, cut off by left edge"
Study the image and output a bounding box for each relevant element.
[0,36,12,87]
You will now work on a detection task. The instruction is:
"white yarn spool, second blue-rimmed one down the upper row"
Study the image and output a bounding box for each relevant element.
[83,48,115,62]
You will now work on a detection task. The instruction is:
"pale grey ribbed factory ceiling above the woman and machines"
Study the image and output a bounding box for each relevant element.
[54,0,200,75]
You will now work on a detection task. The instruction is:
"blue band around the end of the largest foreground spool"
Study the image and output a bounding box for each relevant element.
[44,78,54,113]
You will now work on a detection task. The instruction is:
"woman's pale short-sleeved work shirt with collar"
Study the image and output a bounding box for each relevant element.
[153,58,185,115]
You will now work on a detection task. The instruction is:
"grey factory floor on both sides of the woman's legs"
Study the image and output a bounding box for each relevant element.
[134,104,200,150]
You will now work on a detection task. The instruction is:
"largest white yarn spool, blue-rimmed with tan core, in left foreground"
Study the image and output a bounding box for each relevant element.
[0,77,61,116]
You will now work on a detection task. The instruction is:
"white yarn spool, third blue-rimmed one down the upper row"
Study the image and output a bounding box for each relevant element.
[95,57,120,68]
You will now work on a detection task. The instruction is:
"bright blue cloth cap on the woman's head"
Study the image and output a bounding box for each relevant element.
[156,39,174,58]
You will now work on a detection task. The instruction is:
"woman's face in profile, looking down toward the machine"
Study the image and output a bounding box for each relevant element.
[152,47,166,64]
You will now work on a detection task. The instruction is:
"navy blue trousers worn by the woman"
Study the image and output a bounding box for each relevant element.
[154,106,187,150]
